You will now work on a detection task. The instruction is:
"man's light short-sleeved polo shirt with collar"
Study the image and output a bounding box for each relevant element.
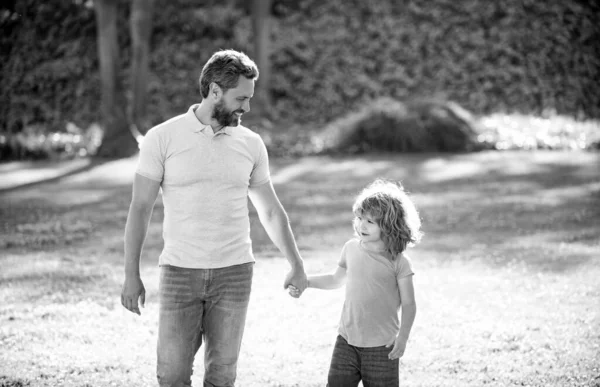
[136,105,270,269]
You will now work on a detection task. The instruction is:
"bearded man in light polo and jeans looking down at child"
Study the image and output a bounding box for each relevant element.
[121,50,307,386]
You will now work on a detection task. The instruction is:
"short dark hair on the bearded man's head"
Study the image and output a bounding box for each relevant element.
[199,50,258,98]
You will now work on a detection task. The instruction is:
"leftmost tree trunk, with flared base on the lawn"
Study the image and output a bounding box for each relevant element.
[94,0,137,158]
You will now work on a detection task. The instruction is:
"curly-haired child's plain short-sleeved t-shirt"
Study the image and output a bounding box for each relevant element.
[338,239,414,347]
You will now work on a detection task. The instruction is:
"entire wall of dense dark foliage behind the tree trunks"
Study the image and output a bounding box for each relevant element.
[0,0,600,159]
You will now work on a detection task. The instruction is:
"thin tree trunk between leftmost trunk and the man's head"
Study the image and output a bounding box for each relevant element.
[129,0,155,136]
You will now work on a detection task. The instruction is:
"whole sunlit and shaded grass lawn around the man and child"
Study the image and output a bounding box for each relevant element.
[0,151,600,387]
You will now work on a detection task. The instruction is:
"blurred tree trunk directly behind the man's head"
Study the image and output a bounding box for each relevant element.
[252,0,272,116]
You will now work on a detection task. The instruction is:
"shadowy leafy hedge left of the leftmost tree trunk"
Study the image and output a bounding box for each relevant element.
[0,0,100,133]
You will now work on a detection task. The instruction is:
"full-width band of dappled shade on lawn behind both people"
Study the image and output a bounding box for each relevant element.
[0,152,600,271]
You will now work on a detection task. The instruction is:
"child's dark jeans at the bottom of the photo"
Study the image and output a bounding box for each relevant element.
[327,336,400,387]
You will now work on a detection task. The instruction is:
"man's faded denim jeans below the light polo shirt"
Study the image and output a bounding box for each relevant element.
[156,262,254,387]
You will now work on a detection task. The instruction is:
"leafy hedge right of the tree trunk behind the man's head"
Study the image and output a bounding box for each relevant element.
[272,0,600,122]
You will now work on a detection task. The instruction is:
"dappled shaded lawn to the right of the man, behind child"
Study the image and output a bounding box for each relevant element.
[252,152,600,271]
